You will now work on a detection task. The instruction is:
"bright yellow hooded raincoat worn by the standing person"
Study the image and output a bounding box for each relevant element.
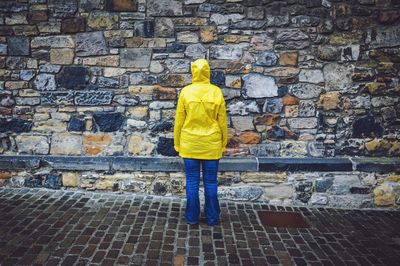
[174,59,228,160]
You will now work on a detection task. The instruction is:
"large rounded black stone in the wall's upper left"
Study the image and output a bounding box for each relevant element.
[56,66,89,89]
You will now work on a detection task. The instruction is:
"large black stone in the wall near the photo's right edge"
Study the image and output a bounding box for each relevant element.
[352,115,383,138]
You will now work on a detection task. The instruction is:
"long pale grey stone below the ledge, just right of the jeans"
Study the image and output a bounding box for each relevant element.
[218,186,264,201]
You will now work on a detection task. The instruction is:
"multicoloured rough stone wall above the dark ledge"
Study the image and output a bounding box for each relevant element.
[0,0,400,157]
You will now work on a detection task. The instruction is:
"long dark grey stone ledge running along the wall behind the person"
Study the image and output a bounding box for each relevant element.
[0,155,400,173]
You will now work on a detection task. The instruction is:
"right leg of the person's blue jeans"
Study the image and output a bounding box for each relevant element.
[203,160,221,225]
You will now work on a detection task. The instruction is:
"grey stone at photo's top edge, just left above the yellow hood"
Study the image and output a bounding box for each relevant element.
[147,0,183,17]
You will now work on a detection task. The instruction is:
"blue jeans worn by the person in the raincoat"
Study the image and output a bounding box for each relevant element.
[183,158,221,225]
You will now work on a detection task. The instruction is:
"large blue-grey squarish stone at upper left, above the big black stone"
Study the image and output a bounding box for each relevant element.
[75,31,108,56]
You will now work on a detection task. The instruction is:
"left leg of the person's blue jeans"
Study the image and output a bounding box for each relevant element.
[184,158,200,224]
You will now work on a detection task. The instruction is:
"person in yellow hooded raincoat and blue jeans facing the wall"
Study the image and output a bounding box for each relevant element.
[174,59,228,226]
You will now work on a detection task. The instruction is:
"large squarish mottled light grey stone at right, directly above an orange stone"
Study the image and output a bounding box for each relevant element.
[324,63,353,91]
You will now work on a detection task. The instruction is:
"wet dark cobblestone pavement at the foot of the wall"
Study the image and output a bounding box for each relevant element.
[0,188,400,265]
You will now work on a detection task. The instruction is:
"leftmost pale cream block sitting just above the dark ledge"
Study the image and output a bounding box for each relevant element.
[16,135,50,154]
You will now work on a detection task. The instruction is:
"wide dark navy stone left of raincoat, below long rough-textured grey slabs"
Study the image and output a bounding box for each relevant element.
[93,113,125,132]
